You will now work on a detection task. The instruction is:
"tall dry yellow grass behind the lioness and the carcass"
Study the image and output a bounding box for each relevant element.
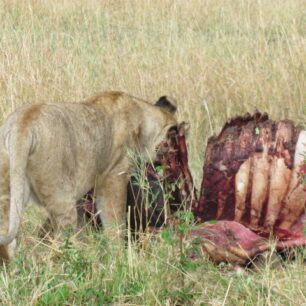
[0,0,306,180]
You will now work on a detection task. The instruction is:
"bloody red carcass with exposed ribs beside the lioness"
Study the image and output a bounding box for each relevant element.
[80,112,306,262]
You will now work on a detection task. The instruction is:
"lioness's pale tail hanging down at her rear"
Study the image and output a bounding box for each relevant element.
[0,129,32,245]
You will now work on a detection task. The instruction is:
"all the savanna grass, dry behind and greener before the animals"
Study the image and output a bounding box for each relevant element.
[0,0,306,305]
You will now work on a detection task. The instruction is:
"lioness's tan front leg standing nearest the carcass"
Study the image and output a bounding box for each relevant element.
[95,171,128,237]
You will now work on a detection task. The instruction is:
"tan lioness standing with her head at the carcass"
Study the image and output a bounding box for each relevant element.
[0,92,177,259]
